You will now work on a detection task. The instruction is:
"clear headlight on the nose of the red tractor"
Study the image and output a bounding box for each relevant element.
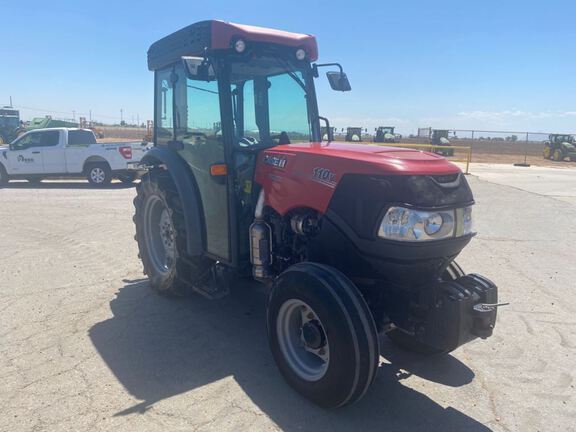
[378,207,472,241]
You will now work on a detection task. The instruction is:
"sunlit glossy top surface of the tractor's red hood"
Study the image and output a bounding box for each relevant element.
[269,142,460,175]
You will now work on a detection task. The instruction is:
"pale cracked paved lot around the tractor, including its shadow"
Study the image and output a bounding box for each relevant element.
[0,169,576,432]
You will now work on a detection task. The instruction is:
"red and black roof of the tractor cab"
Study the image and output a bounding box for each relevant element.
[148,20,318,70]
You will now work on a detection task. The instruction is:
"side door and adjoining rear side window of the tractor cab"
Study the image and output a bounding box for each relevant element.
[156,64,232,263]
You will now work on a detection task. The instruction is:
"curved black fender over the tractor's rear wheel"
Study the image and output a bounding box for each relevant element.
[141,147,206,256]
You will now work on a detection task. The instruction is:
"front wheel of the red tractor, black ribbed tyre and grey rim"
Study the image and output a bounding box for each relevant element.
[267,262,380,408]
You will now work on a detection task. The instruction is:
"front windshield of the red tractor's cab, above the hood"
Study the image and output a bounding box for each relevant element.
[230,55,311,147]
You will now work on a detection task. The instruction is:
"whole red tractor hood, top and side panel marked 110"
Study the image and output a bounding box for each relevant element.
[255,142,465,214]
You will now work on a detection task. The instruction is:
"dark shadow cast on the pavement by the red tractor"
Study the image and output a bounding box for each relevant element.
[89,280,490,431]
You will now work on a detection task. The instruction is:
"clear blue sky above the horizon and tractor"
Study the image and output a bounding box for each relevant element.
[0,0,576,133]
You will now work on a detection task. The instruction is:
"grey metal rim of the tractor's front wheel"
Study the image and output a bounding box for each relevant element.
[276,299,330,381]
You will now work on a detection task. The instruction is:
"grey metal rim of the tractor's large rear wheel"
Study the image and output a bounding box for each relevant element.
[144,196,176,274]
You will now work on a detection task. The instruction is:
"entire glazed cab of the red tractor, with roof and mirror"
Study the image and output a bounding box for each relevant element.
[148,21,350,265]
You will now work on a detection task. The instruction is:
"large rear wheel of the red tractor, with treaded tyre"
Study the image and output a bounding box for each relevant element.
[133,170,214,296]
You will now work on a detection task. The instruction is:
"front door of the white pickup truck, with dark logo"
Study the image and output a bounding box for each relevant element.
[6,132,44,175]
